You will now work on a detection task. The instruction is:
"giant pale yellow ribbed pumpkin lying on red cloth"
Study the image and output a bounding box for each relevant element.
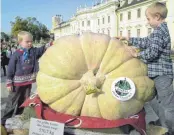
[37,32,154,120]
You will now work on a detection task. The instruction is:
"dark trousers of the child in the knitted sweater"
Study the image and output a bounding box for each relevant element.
[1,84,32,124]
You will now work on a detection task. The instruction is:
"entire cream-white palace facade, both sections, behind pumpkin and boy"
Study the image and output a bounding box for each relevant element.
[52,0,174,48]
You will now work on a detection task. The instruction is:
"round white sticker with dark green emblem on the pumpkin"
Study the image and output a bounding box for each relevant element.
[111,77,135,101]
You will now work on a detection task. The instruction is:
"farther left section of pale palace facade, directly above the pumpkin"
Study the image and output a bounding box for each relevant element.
[52,0,119,38]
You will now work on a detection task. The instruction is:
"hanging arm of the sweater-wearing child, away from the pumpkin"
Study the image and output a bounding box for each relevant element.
[6,54,17,87]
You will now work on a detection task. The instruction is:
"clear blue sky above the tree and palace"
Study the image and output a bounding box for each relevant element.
[1,0,94,34]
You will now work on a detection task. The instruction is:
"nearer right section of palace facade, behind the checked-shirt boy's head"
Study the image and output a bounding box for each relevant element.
[117,0,174,48]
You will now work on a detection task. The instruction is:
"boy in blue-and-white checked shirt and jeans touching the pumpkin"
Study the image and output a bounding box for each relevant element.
[117,2,174,135]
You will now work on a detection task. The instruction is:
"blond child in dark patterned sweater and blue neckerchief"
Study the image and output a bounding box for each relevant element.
[1,31,48,124]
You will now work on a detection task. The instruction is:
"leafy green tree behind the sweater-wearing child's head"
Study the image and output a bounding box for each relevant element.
[11,16,50,41]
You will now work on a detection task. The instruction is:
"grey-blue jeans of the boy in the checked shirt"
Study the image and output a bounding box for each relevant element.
[149,76,174,131]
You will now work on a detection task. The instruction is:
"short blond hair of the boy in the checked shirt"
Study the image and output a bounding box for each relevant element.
[147,2,168,19]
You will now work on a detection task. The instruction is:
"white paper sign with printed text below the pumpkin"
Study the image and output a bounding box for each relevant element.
[29,118,65,135]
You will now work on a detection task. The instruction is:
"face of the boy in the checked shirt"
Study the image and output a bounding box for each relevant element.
[146,10,160,28]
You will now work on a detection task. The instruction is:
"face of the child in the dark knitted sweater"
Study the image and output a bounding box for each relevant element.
[19,35,33,49]
